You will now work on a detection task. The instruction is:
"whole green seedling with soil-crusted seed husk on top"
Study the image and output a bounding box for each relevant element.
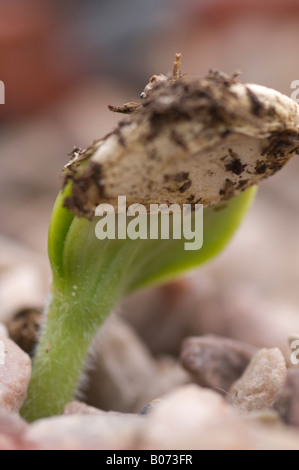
[21,56,299,421]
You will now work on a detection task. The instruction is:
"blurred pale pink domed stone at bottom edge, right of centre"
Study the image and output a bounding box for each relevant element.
[139,385,250,450]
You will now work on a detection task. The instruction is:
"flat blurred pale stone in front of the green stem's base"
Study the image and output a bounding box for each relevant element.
[26,413,143,450]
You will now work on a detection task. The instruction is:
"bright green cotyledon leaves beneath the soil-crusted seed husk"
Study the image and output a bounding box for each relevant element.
[49,183,256,293]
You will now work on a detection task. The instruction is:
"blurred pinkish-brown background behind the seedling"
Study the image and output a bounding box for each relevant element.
[0,0,299,412]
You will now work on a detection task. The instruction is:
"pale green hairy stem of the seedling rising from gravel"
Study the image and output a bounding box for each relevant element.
[22,280,122,421]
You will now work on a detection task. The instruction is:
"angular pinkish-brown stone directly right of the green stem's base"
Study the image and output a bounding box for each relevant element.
[83,316,188,413]
